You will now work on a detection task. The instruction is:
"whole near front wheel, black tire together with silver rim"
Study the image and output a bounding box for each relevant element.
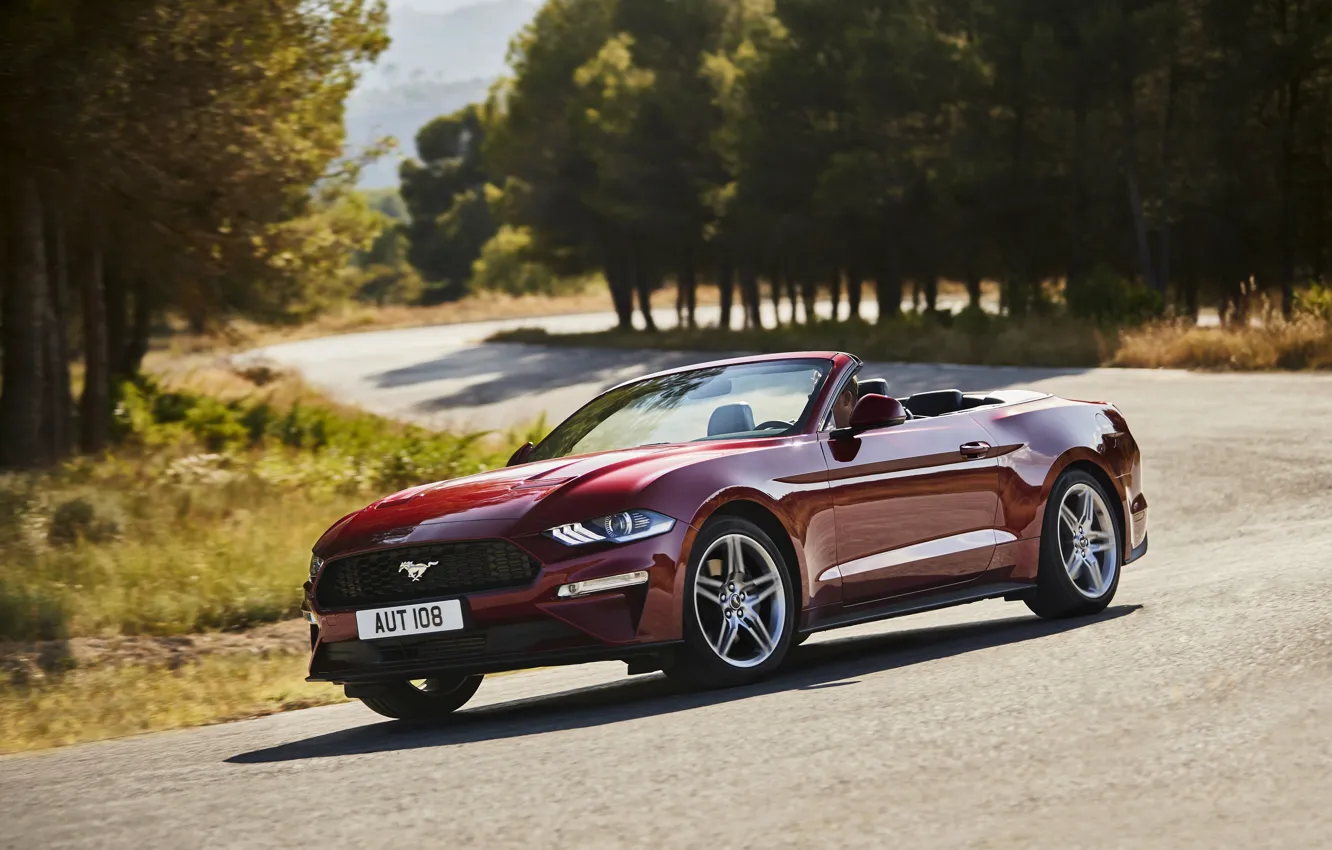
[666,517,799,689]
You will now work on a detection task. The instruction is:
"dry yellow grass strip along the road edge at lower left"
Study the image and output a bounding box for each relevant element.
[0,651,345,753]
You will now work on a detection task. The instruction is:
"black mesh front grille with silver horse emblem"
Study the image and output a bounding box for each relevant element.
[314,540,538,608]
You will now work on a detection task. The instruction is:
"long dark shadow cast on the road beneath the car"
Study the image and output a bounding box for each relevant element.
[226,605,1142,765]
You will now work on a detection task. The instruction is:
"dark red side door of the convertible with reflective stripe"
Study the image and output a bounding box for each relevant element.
[822,413,999,605]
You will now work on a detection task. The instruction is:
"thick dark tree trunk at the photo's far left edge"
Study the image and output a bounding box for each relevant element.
[0,177,52,466]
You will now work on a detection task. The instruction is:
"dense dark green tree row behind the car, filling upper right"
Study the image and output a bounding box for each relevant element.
[471,0,1332,325]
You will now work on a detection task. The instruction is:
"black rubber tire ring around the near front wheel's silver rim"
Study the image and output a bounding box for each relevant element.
[667,517,799,687]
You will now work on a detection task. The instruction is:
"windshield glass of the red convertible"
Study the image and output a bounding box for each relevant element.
[530,360,831,461]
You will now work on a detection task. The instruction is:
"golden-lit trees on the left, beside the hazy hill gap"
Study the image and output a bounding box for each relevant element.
[0,0,385,465]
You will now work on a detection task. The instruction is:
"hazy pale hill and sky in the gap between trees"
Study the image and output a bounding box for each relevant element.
[346,0,539,188]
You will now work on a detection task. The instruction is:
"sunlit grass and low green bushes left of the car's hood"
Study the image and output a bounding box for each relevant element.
[0,381,545,639]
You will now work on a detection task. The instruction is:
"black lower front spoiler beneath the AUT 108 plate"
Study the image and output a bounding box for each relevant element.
[305,622,678,685]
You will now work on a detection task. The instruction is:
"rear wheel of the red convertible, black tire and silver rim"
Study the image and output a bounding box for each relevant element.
[1027,469,1124,620]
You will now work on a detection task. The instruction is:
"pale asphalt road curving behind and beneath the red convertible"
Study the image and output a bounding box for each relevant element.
[0,318,1332,850]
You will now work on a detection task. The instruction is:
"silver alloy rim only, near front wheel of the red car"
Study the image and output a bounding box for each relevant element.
[694,533,787,667]
